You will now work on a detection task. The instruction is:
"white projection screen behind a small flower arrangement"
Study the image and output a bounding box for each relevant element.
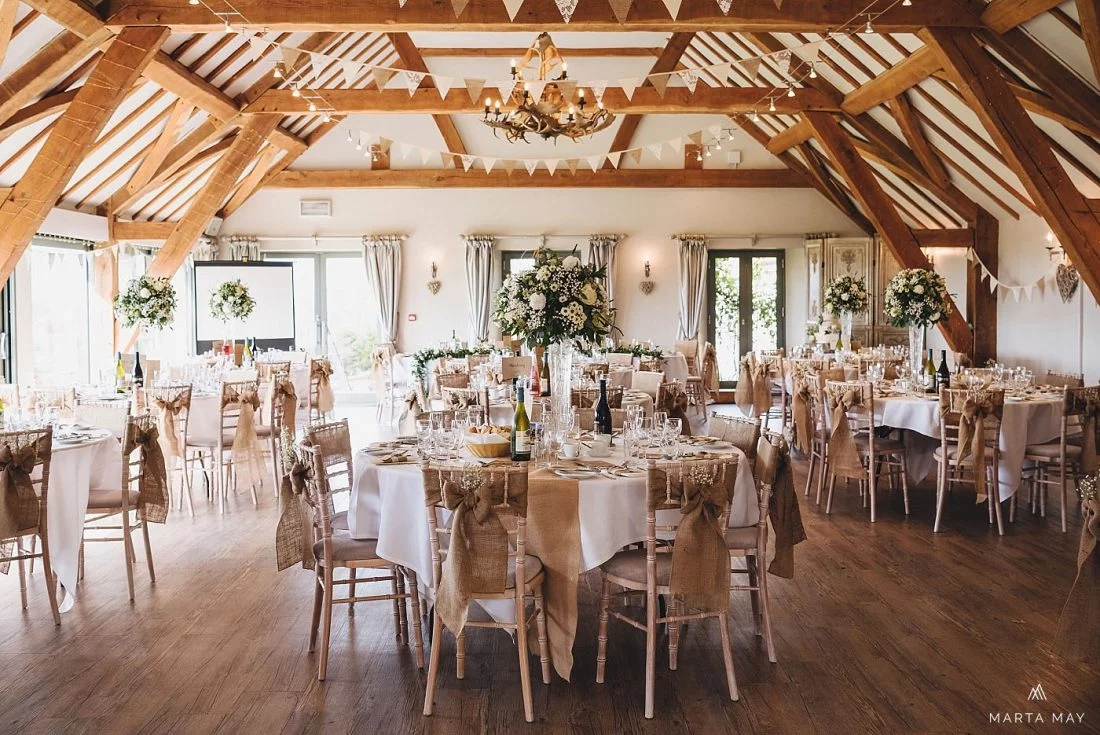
[195,261,295,354]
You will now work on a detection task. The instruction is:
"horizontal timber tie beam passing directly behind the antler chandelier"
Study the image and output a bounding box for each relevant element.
[244,85,838,116]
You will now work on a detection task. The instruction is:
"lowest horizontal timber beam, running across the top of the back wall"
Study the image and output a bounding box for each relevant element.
[264,163,807,189]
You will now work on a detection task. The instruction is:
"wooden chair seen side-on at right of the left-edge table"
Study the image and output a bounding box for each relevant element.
[80,414,167,602]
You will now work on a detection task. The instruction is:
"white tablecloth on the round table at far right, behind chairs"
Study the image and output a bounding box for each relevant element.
[875,397,1062,501]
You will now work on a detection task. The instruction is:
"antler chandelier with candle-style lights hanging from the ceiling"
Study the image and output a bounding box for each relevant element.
[482,33,615,143]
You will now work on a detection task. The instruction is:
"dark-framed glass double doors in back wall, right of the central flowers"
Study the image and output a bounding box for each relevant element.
[706,250,787,388]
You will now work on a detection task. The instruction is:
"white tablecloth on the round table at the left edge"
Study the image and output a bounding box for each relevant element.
[46,436,122,613]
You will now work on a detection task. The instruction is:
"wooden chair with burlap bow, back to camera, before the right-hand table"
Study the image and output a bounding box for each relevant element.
[933,388,1004,536]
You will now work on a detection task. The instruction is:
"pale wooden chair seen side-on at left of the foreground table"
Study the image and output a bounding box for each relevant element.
[303,421,424,681]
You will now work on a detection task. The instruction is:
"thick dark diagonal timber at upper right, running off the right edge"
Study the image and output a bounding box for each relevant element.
[921,29,1100,298]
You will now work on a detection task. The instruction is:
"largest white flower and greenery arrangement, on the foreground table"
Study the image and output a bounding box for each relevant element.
[493,248,615,350]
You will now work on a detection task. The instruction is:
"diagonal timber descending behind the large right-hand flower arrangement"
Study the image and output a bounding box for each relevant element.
[806,112,972,353]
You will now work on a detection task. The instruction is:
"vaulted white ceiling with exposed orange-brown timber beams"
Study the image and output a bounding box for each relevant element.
[0,0,1100,310]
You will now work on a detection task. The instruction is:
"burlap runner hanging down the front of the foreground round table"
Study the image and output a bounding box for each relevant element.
[527,469,581,681]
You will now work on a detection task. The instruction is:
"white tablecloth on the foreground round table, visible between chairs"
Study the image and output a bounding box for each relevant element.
[348,449,760,589]
